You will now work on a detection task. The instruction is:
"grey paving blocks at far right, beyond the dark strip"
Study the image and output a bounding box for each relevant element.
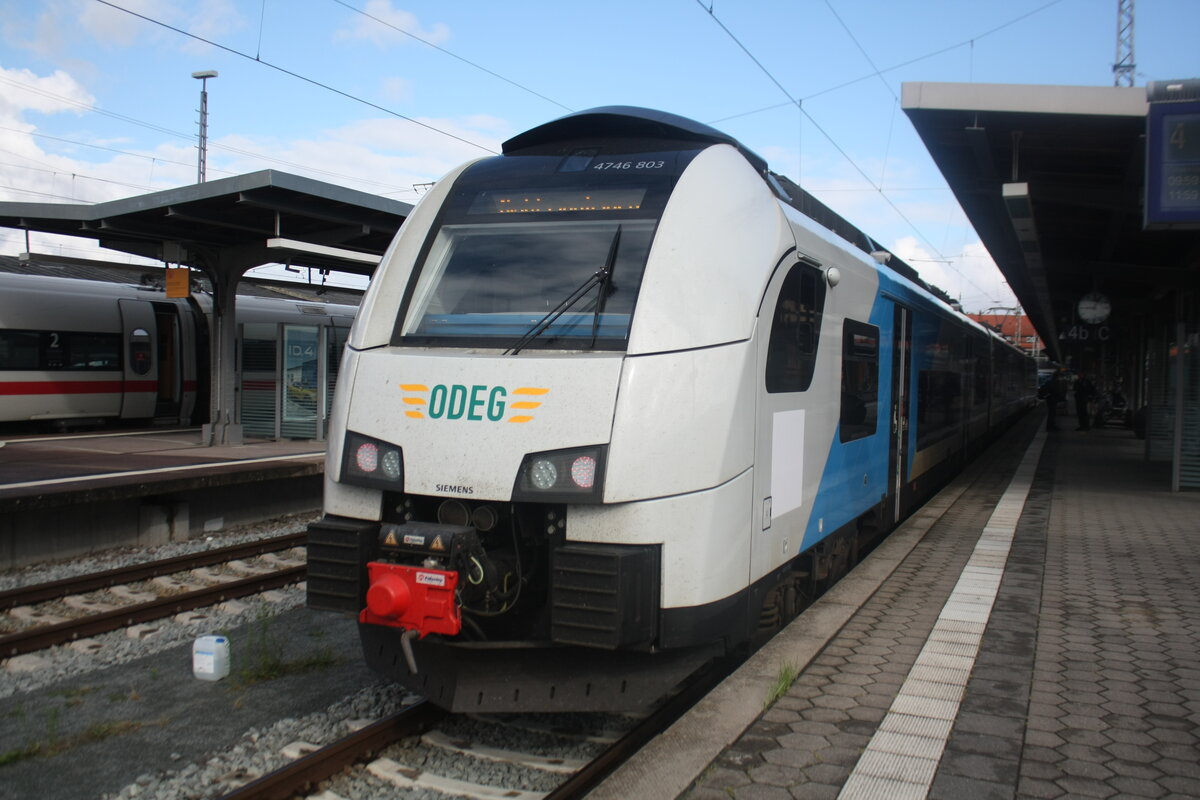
[1018,431,1200,799]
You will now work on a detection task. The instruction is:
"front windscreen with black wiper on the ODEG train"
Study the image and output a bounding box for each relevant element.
[403,219,655,347]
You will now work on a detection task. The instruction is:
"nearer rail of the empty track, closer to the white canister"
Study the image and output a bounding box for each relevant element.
[0,566,308,658]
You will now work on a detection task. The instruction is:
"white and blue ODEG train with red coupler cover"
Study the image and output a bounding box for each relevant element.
[308,107,1034,711]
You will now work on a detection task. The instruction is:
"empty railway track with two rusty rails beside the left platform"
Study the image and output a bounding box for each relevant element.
[0,533,307,658]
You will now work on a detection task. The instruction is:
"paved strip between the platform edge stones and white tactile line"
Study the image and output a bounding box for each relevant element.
[686,417,1041,800]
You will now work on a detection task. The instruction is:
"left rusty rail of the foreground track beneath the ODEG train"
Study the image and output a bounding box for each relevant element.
[221,700,446,800]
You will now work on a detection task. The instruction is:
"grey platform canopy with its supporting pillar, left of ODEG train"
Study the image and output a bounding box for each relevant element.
[0,169,413,444]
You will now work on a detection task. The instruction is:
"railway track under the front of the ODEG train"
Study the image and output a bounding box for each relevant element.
[212,663,736,800]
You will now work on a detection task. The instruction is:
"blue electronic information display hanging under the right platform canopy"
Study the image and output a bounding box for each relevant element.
[1145,102,1200,228]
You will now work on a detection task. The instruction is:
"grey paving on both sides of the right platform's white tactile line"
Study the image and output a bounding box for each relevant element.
[684,419,1200,800]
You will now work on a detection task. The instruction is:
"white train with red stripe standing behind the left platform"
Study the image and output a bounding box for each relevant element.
[0,272,358,431]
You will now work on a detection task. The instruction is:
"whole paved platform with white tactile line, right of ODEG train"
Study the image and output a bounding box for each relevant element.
[597,413,1200,800]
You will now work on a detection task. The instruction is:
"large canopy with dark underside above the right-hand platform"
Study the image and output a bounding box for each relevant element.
[901,83,1200,361]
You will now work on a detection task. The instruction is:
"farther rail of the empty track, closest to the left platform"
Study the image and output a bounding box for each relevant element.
[0,533,308,610]
